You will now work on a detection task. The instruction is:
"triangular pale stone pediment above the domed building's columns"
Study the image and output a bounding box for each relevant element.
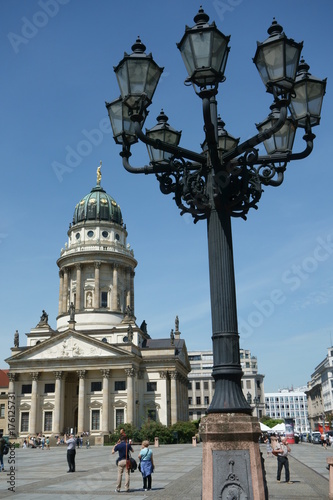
[7,330,128,362]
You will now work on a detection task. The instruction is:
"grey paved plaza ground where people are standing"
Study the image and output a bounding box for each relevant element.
[0,443,333,500]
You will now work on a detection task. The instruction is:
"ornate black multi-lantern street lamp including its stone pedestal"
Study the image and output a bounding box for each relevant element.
[106,8,326,500]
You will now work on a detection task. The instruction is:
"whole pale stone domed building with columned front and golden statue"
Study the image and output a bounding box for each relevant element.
[6,165,191,442]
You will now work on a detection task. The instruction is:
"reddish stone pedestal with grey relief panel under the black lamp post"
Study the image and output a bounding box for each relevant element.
[199,413,268,500]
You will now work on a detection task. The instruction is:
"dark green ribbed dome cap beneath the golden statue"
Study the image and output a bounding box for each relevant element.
[73,183,123,226]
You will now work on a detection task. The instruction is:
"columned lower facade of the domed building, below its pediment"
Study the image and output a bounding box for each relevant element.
[9,366,184,437]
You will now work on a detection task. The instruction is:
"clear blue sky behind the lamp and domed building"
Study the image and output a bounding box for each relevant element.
[0,0,333,392]
